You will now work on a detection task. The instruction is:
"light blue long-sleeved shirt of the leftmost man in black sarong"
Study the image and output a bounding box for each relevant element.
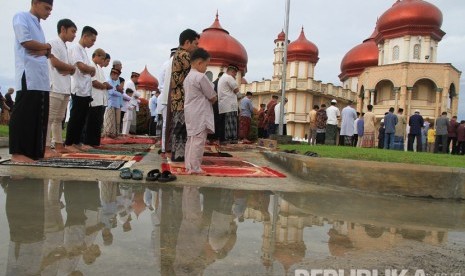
[13,12,50,91]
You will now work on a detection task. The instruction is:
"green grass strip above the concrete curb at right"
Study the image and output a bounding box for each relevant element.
[279,144,465,168]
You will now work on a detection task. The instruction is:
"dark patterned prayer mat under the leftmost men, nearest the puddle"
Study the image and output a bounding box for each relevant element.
[0,158,126,170]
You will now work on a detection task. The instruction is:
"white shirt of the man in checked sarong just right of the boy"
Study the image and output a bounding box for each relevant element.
[218,74,238,114]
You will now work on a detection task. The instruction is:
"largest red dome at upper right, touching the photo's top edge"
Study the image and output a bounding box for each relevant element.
[376,0,445,42]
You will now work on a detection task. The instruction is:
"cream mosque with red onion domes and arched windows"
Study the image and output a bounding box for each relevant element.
[135,0,461,138]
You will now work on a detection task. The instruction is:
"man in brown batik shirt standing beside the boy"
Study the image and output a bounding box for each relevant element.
[165,29,200,162]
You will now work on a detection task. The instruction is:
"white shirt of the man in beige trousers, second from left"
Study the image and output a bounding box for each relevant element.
[48,37,71,95]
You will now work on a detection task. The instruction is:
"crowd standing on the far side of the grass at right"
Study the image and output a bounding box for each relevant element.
[308,100,465,155]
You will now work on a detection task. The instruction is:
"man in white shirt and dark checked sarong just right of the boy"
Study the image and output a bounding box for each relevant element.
[218,65,239,144]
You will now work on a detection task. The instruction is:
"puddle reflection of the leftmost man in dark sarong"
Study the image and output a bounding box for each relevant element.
[5,179,45,275]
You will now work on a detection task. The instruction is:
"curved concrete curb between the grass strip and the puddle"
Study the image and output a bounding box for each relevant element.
[263,152,465,199]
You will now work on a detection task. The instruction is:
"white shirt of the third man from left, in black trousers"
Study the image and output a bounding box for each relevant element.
[69,43,92,97]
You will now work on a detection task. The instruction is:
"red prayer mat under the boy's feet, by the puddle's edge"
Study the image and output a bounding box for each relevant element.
[161,157,286,178]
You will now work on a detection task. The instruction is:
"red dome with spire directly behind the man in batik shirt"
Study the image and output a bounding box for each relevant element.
[199,14,248,75]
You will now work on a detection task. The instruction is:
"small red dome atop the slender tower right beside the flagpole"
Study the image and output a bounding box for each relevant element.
[287,28,319,63]
